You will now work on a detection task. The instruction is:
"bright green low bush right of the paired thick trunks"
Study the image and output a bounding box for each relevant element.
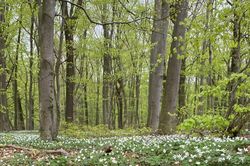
[178,115,229,135]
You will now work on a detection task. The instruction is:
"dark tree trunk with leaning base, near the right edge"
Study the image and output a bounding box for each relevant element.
[226,0,250,136]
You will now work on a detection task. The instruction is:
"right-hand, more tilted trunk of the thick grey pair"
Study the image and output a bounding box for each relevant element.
[159,0,188,134]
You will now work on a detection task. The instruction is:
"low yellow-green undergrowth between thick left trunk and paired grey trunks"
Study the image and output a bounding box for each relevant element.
[60,123,151,138]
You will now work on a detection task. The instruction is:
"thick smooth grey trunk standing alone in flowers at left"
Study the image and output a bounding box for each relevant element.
[39,0,58,141]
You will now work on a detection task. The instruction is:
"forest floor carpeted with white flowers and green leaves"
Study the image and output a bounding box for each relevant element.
[0,132,250,166]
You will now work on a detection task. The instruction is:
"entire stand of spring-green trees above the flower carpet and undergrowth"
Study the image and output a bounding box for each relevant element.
[0,0,250,140]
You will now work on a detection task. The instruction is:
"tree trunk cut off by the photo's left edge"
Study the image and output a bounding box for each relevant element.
[0,1,12,131]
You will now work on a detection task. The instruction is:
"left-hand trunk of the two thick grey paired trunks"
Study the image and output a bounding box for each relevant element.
[147,0,169,131]
